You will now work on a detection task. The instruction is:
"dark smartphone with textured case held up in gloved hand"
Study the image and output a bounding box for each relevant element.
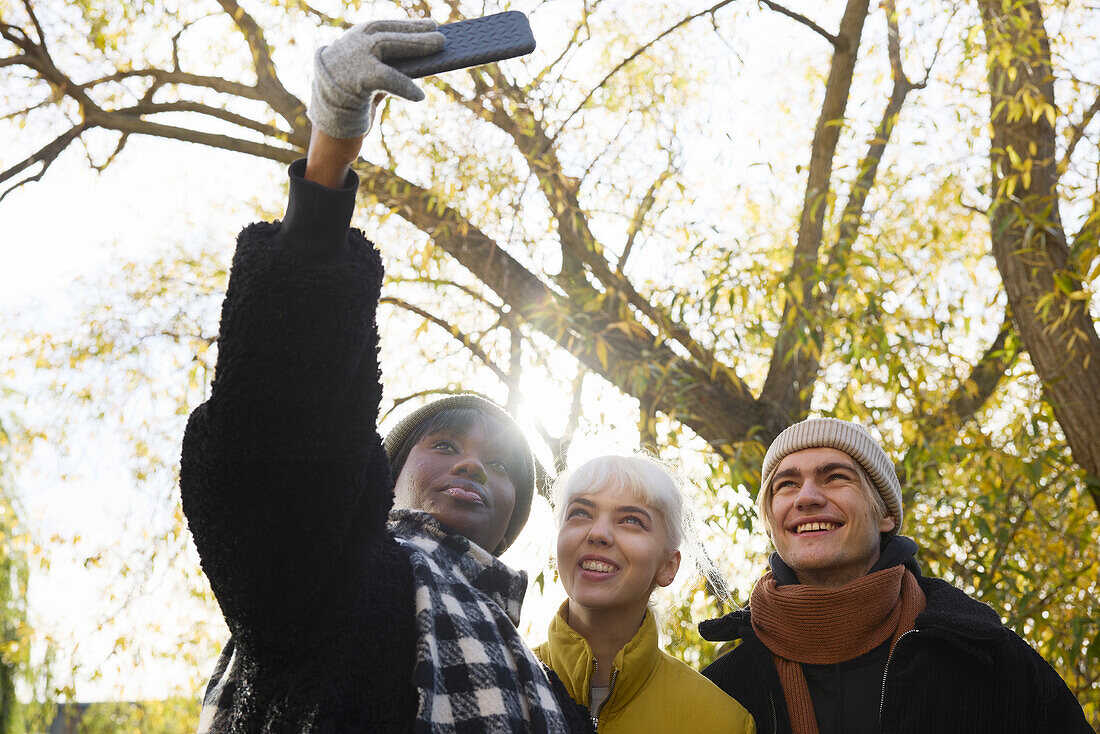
[386,10,535,79]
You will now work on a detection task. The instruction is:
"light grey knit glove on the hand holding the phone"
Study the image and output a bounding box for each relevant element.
[308,20,444,138]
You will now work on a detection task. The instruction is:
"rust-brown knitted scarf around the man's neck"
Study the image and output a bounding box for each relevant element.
[749,566,924,734]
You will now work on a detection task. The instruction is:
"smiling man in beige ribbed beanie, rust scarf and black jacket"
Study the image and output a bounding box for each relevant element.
[700,418,1092,734]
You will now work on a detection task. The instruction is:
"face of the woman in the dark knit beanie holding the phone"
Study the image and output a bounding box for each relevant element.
[394,421,517,552]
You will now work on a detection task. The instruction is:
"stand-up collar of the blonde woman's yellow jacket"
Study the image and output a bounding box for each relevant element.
[540,601,661,719]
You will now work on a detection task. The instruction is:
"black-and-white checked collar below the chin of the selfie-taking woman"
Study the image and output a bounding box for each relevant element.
[388,510,527,626]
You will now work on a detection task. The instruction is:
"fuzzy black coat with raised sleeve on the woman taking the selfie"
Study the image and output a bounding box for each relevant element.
[180,162,590,734]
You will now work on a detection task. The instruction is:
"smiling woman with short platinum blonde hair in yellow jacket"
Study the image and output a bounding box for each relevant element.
[535,453,756,734]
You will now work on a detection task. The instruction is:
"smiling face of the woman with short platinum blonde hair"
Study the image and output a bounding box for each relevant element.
[558,487,680,621]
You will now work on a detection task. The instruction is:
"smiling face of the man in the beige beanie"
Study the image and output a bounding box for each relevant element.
[769,448,894,589]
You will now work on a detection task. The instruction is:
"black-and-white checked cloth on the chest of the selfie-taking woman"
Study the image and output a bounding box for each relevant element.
[389,510,567,734]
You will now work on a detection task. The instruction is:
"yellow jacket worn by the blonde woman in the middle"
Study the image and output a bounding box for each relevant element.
[535,602,756,734]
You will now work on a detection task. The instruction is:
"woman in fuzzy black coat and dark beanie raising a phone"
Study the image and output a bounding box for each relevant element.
[180,21,590,733]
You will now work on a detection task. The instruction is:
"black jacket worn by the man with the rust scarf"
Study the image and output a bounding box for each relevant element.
[699,577,1092,734]
